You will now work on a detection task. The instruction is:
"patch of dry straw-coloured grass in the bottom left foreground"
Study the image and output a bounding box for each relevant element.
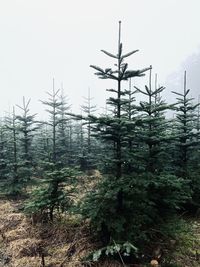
[0,200,103,267]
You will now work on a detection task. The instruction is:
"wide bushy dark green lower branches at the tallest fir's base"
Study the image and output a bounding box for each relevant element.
[82,173,190,247]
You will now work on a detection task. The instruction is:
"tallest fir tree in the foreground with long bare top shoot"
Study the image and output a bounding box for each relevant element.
[81,22,149,243]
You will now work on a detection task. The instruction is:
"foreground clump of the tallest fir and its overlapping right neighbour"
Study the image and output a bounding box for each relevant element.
[82,24,192,253]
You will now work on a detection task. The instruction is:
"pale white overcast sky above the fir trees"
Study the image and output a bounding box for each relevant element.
[0,0,200,117]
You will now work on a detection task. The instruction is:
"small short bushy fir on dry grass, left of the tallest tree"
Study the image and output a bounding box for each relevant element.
[25,163,75,221]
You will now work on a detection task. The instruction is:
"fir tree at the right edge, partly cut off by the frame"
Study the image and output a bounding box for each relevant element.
[173,71,200,210]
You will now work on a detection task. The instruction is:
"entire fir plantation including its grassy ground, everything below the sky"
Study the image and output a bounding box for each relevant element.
[0,22,200,267]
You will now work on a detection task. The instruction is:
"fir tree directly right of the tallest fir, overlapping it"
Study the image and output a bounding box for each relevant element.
[130,68,189,222]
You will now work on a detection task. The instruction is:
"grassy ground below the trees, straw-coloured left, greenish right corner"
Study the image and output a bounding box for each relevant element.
[0,176,200,267]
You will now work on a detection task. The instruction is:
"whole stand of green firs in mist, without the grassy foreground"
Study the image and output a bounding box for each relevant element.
[0,23,200,266]
